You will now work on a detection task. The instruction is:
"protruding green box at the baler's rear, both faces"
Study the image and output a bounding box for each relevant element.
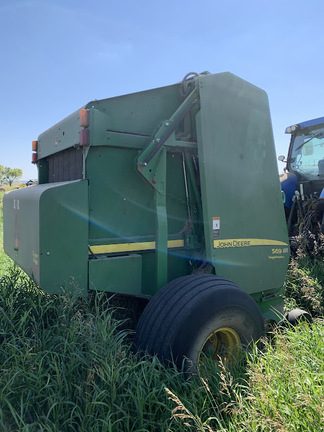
[4,181,89,294]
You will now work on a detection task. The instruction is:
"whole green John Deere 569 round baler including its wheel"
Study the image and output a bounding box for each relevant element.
[4,73,289,364]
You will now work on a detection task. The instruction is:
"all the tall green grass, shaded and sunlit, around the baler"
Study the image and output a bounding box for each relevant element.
[0,192,324,432]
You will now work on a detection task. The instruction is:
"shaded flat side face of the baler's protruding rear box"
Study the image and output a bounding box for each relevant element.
[40,181,89,294]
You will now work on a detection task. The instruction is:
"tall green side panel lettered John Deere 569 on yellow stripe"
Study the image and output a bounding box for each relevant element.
[197,74,289,294]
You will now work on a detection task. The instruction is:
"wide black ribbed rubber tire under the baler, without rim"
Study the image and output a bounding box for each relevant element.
[134,274,264,367]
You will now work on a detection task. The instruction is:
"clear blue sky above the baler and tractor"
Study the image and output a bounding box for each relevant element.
[0,0,324,179]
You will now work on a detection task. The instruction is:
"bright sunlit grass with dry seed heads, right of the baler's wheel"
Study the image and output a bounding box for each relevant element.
[169,321,324,432]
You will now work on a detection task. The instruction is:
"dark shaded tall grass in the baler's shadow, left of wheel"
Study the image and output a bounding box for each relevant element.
[0,268,239,432]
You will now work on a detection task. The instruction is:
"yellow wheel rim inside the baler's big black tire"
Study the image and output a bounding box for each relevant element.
[198,327,241,364]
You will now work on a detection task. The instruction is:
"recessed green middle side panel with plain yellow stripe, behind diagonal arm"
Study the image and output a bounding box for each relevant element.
[86,85,199,295]
